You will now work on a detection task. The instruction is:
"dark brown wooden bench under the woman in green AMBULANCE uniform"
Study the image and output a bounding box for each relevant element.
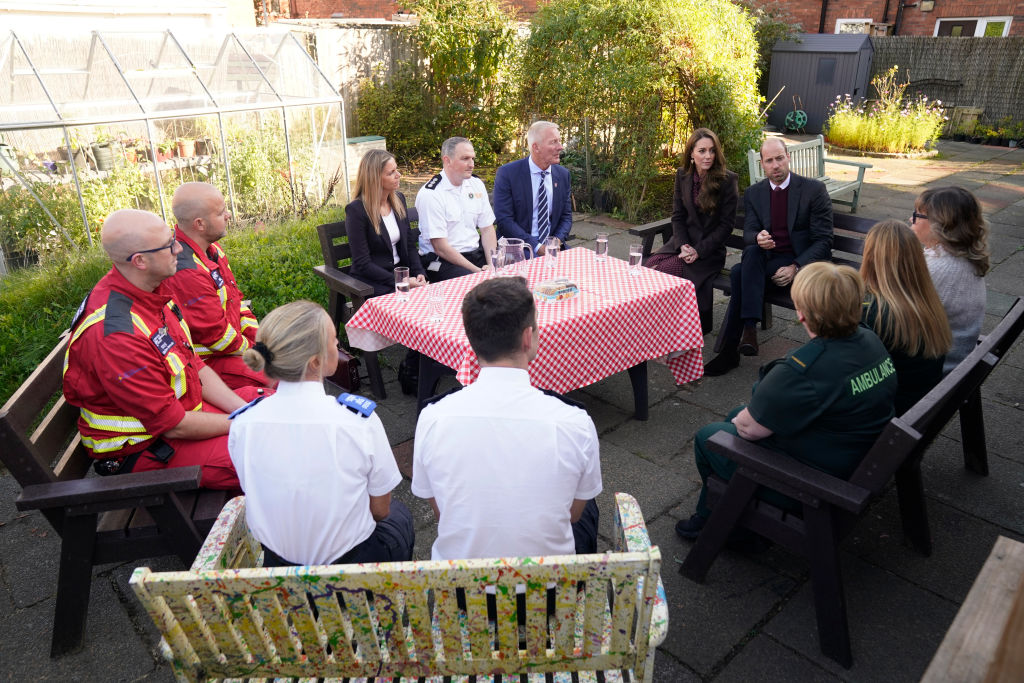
[680,299,1024,668]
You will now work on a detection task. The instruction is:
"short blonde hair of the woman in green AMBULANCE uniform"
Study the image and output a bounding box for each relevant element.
[792,261,864,339]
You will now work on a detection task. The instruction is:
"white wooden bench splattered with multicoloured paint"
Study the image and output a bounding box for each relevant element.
[130,494,668,683]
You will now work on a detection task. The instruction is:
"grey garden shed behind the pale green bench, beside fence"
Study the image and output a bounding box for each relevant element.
[768,34,873,133]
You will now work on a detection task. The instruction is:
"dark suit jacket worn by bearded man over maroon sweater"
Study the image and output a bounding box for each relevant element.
[743,173,833,266]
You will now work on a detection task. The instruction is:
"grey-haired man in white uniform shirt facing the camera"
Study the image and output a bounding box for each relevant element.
[416,137,497,283]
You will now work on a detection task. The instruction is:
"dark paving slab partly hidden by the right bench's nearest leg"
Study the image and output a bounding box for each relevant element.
[764,553,956,683]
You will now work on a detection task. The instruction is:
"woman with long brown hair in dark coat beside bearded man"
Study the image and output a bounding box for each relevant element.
[646,128,739,334]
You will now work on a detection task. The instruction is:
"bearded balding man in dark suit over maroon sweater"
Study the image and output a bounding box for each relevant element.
[705,137,833,377]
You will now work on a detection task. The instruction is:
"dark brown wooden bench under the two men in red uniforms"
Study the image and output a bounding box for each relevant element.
[0,337,227,656]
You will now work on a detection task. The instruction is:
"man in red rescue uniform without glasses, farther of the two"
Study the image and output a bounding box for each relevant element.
[165,182,270,389]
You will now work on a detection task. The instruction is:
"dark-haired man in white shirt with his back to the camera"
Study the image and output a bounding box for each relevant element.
[412,278,601,560]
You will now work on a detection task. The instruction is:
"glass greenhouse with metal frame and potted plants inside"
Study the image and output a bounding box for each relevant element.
[0,31,348,274]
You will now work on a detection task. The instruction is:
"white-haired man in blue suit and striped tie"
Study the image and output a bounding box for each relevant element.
[495,121,572,256]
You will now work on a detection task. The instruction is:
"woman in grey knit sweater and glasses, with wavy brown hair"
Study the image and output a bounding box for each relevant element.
[910,187,988,373]
